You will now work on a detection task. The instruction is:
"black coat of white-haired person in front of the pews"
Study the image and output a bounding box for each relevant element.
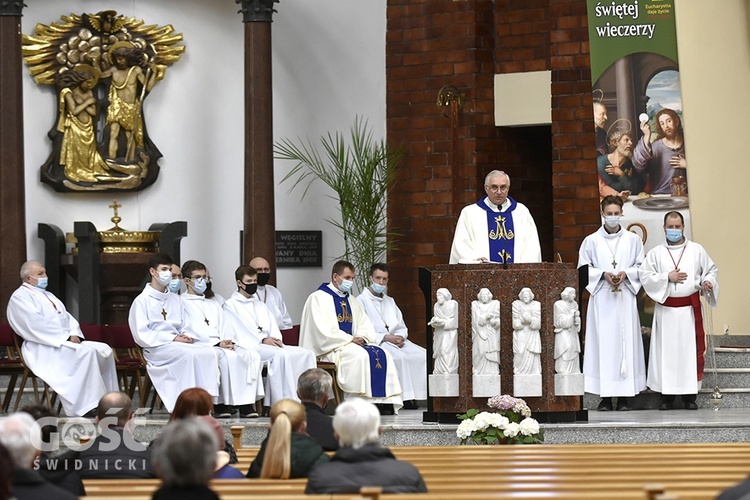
[305,443,427,494]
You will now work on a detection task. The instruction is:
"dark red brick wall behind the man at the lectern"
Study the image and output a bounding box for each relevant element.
[386,0,599,345]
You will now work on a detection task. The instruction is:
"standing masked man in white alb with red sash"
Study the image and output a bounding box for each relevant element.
[639,212,719,410]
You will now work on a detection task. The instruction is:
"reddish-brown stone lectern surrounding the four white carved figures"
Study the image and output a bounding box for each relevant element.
[419,263,588,422]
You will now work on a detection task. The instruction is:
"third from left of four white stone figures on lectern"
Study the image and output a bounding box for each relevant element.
[513,287,542,375]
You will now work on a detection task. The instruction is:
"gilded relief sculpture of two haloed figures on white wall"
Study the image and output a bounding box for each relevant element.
[23,10,185,192]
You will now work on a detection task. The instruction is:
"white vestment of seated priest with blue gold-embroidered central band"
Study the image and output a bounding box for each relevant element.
[299,283,404,411]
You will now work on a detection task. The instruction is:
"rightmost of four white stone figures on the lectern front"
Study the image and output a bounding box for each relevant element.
[554,286,581,374]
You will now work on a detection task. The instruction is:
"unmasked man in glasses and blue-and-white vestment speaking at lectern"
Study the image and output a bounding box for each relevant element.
[450,170,542,264]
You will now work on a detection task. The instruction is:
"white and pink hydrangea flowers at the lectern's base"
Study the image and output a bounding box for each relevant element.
[456,395,544,444]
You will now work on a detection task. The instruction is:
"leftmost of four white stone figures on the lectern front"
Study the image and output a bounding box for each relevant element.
[430,288,458,375]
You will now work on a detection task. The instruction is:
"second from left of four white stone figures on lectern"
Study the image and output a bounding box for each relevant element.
[471,288,500,375]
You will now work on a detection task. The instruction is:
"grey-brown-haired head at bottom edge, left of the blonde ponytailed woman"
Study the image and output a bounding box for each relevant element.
[152,418,219,500]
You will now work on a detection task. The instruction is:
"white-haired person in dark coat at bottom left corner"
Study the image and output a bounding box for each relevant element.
[0,412,78,500]
